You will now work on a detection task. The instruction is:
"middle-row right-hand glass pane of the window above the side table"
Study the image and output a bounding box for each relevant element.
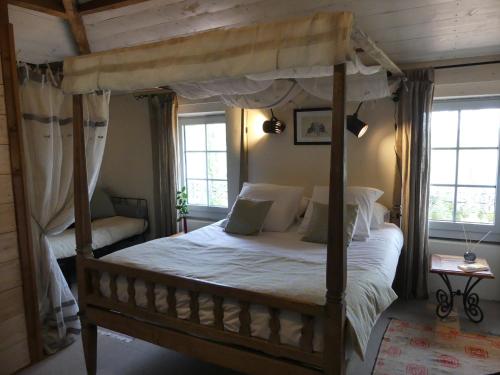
[458,150,498,186]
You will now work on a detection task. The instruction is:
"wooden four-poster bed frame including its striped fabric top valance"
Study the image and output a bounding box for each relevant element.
[63,12,402,375]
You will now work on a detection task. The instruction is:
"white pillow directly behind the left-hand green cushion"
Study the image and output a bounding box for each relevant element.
[239,182,304,232]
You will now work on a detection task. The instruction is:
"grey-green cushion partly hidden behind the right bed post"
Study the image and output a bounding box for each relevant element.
[302,202,358,245]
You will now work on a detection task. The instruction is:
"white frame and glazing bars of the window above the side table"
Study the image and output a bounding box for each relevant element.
[429,96,500,242]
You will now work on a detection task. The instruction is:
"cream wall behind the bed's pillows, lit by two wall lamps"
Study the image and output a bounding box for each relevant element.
[247,95,396,208]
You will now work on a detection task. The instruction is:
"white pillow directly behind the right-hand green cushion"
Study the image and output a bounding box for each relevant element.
[299,186,384,241]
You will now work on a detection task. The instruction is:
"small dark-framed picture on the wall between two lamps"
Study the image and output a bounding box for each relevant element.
[293,108,332,145]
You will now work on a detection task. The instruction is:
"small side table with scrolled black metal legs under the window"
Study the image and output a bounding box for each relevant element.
[430,254,495,323]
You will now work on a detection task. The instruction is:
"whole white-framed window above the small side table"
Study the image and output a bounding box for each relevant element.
[429,98,500,241]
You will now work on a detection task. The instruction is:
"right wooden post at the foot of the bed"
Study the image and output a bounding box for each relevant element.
[323,64,347,375]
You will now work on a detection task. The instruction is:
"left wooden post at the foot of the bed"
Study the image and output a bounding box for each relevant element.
[73,95,97,375]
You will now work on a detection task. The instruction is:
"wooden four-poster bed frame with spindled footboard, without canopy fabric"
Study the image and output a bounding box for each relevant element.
[66,12,397,375]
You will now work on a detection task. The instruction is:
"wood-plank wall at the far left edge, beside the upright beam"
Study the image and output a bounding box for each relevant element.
[0,58,30,374]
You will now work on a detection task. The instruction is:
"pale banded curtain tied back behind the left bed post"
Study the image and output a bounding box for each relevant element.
[20,66,110,353]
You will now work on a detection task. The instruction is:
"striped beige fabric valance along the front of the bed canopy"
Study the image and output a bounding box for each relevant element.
[63,12,353,94]
